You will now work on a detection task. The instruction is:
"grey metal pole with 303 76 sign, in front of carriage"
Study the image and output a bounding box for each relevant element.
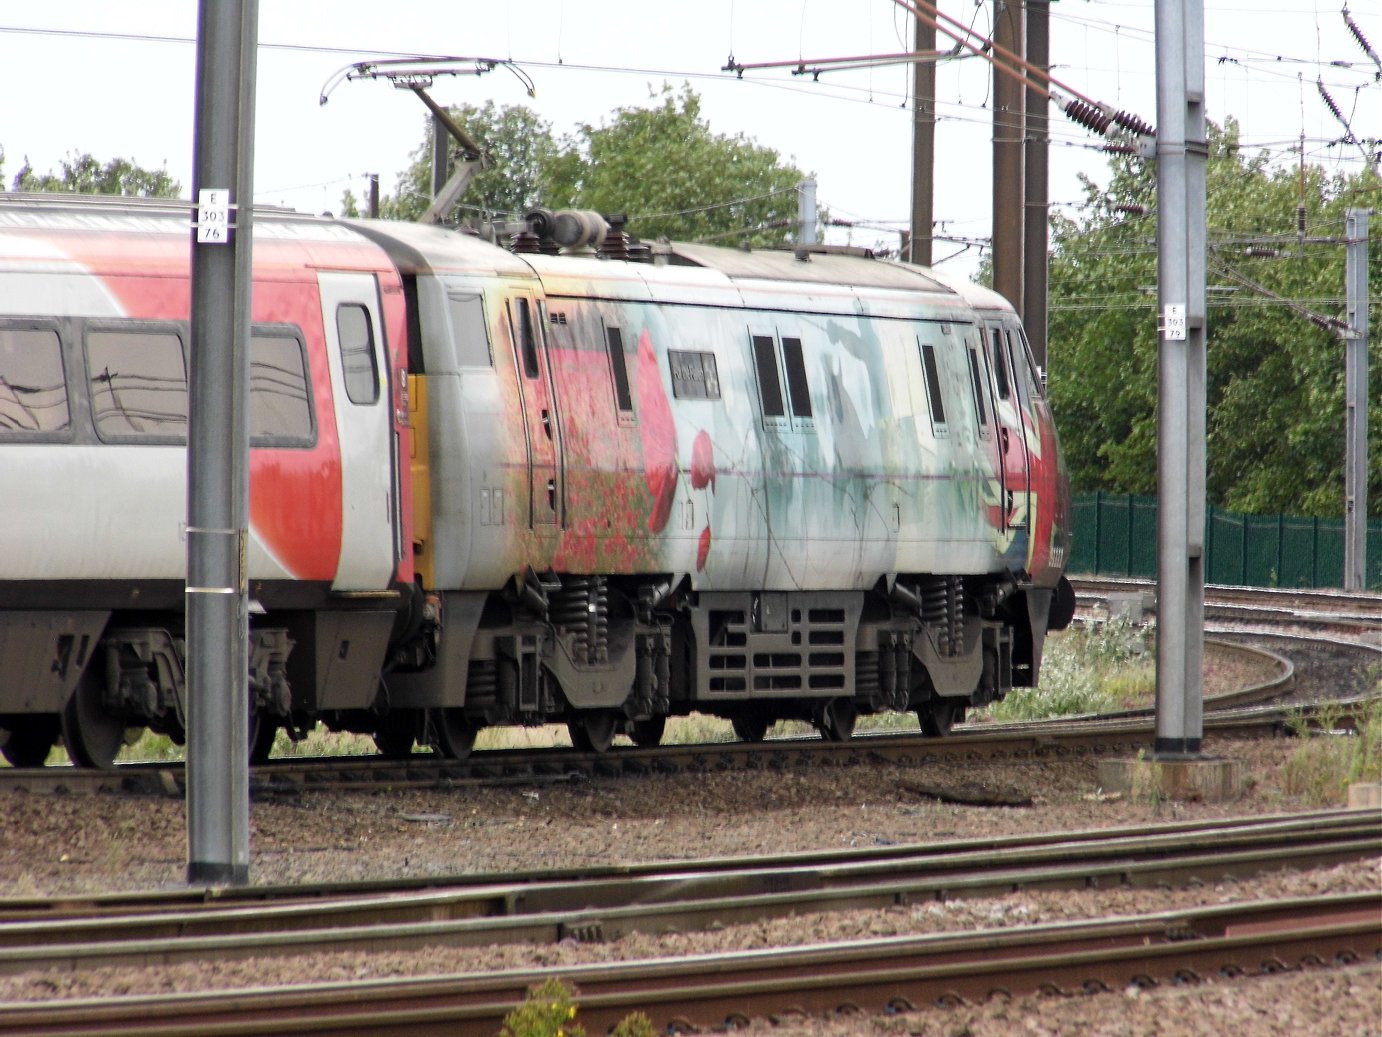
[187,0,258,884]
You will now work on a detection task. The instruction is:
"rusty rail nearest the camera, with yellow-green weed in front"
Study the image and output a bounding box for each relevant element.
[0,893,1382,1037]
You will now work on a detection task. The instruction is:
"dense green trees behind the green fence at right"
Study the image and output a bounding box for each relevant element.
[1049,120,1382,516]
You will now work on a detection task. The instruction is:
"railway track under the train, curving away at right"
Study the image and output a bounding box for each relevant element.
[0,579,1382,798]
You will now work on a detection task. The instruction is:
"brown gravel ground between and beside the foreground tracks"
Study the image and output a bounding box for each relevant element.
[0,740,1382,1037]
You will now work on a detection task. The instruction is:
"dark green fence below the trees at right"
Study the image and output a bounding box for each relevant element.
[1070,492,1382,590]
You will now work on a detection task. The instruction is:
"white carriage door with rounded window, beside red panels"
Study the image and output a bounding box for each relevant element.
[316,272,399,590]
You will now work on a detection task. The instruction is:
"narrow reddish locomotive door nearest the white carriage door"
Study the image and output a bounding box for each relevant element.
[507,292,565,534]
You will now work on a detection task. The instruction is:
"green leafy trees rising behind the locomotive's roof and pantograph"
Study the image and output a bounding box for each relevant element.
[373,87,804,246]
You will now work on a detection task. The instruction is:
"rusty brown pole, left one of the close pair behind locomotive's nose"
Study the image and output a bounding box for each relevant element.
[994,0,1027,317]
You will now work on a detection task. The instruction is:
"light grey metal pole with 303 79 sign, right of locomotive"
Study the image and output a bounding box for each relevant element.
[1154,0,1208,755]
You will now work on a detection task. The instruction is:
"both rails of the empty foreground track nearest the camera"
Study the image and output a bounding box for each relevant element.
[0,810,1382,1034]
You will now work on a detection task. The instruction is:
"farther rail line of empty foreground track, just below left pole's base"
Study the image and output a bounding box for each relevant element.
[0,810,1382,975]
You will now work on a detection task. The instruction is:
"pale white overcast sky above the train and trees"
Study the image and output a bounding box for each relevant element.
[0,0,1382,275]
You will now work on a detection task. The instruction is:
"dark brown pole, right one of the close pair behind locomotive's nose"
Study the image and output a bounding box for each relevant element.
[1023,0,1050,371]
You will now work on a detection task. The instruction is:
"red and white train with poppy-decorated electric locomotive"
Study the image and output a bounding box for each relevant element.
[0,192,1074,767]
